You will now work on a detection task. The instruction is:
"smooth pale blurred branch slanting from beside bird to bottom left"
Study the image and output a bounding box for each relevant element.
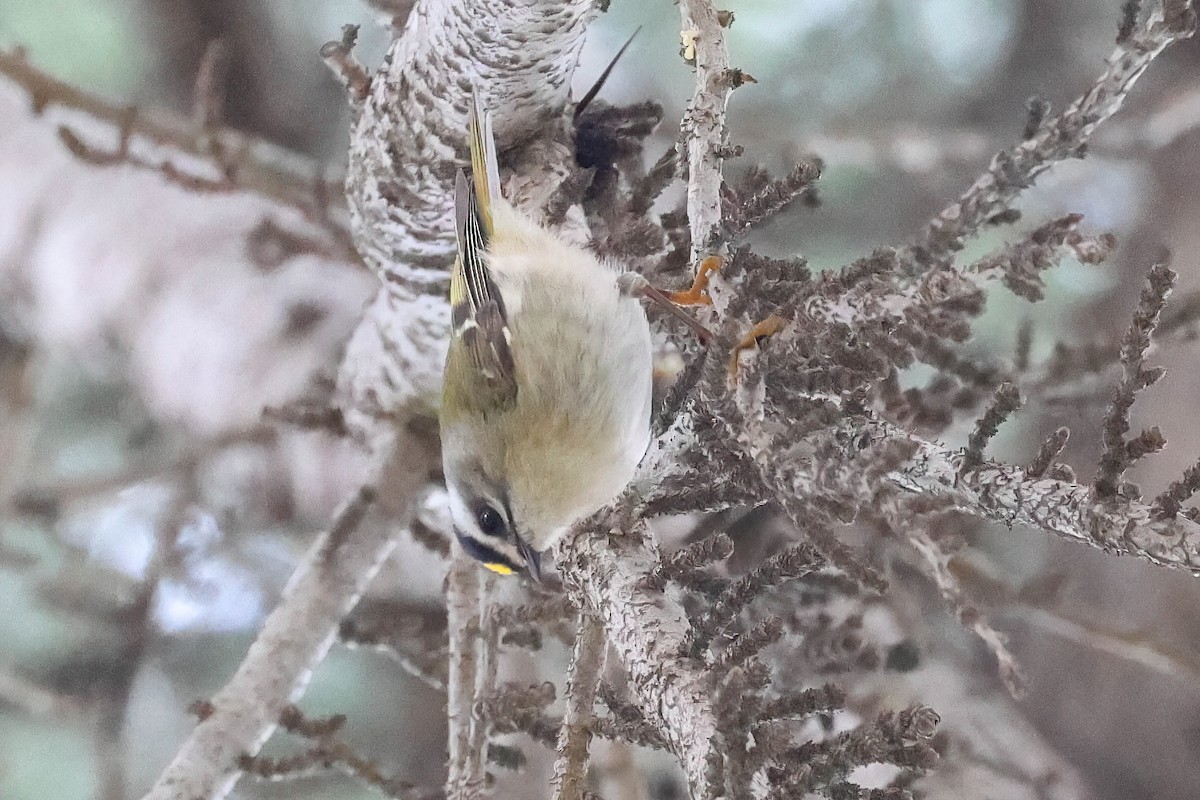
[145,434,434,800]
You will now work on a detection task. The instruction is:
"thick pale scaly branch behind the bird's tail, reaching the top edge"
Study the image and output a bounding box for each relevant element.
[338,0,598,435]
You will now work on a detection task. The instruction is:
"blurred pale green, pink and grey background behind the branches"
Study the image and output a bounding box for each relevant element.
[0,0,1200,800]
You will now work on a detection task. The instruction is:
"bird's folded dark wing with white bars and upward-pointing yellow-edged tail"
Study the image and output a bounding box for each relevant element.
[450,97,517,399]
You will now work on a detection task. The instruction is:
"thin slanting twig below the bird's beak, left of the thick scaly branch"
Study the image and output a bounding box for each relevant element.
[553,613,607,800]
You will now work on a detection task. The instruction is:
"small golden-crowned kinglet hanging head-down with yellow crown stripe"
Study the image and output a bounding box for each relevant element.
[440,98,656,581]
